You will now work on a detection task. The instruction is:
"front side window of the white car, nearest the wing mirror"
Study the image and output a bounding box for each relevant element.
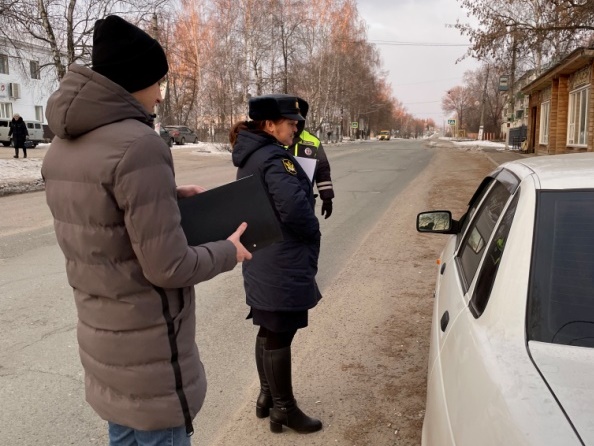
[458,181,511,290]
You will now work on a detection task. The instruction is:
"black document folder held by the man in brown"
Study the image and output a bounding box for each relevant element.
[178,175,283,252]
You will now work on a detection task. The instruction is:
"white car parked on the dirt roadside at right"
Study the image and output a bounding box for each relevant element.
[417,153,594,446]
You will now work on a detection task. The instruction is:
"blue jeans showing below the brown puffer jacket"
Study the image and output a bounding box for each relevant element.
[108,422,191,446]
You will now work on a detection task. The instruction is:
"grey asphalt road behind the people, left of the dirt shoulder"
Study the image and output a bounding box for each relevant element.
[0,140,435,446]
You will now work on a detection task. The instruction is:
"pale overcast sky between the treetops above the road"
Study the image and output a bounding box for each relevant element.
[357,0,479,126]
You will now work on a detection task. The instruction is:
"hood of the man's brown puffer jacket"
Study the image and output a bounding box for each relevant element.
[46,64,153,139]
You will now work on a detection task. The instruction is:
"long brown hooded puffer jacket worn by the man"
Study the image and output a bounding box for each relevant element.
[41,65,237,431]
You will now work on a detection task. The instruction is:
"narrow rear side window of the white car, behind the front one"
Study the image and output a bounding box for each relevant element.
[470,193,520,318]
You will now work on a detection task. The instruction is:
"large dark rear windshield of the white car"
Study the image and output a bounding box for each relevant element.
[527,190,594,347]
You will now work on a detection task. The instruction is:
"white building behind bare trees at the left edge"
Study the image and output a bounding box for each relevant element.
[0,39,58,124]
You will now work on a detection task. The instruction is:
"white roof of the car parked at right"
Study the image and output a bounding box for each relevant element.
[501,152,594,189]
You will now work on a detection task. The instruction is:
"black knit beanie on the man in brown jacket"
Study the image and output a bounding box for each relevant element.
[92,15,169,93]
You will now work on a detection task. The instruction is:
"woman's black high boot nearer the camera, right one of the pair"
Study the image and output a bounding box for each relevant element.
[264,347,322,434]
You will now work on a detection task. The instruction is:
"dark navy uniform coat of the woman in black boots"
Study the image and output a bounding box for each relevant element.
[233,130,320,311]
